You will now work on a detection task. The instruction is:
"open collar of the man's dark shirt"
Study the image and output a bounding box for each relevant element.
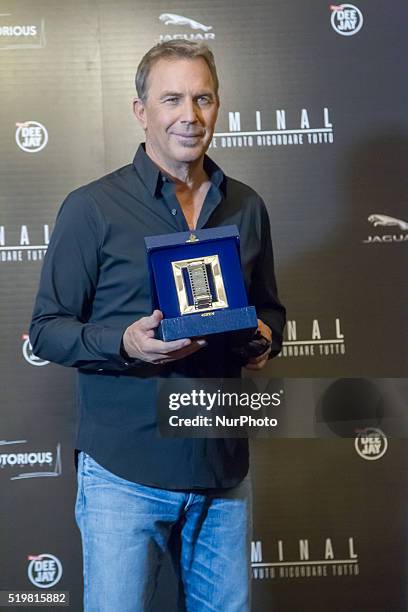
[133,143,225,196]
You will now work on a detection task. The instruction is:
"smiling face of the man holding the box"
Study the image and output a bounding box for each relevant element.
[134,58,219,167]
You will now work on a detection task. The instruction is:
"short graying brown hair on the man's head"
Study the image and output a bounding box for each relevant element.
[135,40,219,103]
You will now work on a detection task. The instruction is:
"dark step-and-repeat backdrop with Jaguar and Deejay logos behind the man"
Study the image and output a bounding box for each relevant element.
[0,0,408,612]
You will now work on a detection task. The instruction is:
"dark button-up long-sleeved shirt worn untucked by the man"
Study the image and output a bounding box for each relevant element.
[30,145,285,489]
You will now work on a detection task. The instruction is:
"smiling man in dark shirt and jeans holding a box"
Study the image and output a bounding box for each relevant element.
[30,41,285,612]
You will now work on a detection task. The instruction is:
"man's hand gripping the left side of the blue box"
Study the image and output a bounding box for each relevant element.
[123,310,207,364]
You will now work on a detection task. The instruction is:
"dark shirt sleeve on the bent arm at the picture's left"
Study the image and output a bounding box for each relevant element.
[29,191,143,370]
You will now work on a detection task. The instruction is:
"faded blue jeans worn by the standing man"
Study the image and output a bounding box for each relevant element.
[75,452,252,612]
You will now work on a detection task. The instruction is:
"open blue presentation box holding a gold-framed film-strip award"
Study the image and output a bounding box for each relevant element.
[145,225,258,343]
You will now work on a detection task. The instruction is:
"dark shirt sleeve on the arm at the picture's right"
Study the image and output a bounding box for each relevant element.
[249,200,286,358]
